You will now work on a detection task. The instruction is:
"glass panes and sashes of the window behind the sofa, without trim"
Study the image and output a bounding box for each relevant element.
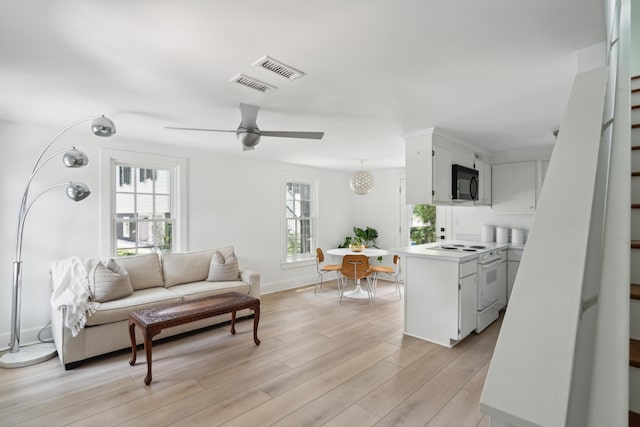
[112,163,174,256]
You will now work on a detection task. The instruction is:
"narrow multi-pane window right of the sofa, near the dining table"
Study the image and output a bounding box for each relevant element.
[284,179,315,262]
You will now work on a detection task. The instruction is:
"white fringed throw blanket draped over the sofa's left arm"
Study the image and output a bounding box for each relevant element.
[51,257,99,337]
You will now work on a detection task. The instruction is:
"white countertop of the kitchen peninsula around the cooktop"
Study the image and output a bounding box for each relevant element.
[389,240,524,263]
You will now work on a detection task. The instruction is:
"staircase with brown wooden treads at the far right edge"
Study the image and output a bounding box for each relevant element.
[629,76,640,426]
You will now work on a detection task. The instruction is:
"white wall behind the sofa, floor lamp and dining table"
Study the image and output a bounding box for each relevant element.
[0,122,399,350]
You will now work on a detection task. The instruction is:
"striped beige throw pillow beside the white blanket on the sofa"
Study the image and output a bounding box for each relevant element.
[89,259,133,302]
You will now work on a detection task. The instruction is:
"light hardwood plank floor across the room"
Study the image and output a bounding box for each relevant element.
[0,281,500,427]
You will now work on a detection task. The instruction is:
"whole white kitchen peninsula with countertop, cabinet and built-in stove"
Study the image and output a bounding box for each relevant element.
[391,241,510,347]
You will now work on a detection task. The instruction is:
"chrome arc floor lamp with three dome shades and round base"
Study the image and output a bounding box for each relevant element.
[0,116,116,368]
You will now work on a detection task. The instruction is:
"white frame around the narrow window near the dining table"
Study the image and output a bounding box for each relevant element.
[280,174,319,268]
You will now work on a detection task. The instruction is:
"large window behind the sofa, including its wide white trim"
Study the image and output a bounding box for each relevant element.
[101,148,187,256]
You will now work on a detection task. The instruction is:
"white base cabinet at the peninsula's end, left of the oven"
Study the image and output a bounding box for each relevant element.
[404,256,478,347]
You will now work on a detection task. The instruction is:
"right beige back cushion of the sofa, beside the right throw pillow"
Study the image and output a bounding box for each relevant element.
[162,249,213,288]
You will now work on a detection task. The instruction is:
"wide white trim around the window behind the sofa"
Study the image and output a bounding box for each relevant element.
[99,147,188,256]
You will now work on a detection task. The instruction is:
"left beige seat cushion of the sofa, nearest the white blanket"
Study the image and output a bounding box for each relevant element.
[87,287,182,328]
